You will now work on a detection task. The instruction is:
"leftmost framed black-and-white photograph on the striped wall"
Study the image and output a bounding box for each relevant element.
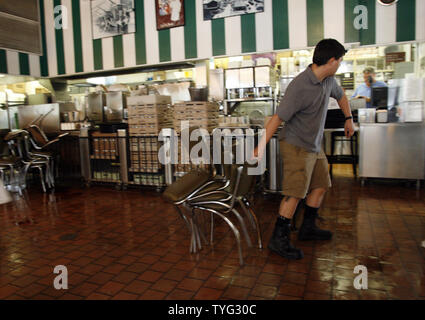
[91,0,136,39]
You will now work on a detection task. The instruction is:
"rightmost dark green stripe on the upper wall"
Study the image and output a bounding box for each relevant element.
[397,0,416,41]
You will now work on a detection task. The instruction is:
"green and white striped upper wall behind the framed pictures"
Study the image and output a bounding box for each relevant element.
[0,0,425,77]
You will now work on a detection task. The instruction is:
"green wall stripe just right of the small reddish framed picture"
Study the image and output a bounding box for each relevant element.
[184,0,198,59]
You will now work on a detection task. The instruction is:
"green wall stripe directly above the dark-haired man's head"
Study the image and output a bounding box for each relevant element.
[307,0,325,47]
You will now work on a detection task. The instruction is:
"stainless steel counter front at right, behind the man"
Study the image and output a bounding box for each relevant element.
[359,123,425,185]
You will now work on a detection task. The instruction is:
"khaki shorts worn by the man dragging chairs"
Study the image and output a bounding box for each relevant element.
[280,140,332,199]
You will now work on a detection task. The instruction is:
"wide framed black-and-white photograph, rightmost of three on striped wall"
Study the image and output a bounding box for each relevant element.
[202,0,264,20]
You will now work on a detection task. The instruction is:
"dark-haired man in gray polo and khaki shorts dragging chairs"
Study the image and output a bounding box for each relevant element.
[254,39,354,259]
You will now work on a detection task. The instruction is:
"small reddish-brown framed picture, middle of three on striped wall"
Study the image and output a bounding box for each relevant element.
[155,0,184,30]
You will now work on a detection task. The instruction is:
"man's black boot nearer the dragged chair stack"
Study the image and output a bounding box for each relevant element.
[268,217,304,260]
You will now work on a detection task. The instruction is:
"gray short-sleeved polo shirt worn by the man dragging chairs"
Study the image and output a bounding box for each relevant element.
[276,65,344,152]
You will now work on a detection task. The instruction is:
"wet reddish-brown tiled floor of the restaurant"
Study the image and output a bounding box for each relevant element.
[0,167,425,300]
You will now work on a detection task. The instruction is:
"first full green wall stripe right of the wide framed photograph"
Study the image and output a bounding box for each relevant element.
[273,0,289,50]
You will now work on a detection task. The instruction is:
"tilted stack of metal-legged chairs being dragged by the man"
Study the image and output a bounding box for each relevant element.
[163,142,262,265]
